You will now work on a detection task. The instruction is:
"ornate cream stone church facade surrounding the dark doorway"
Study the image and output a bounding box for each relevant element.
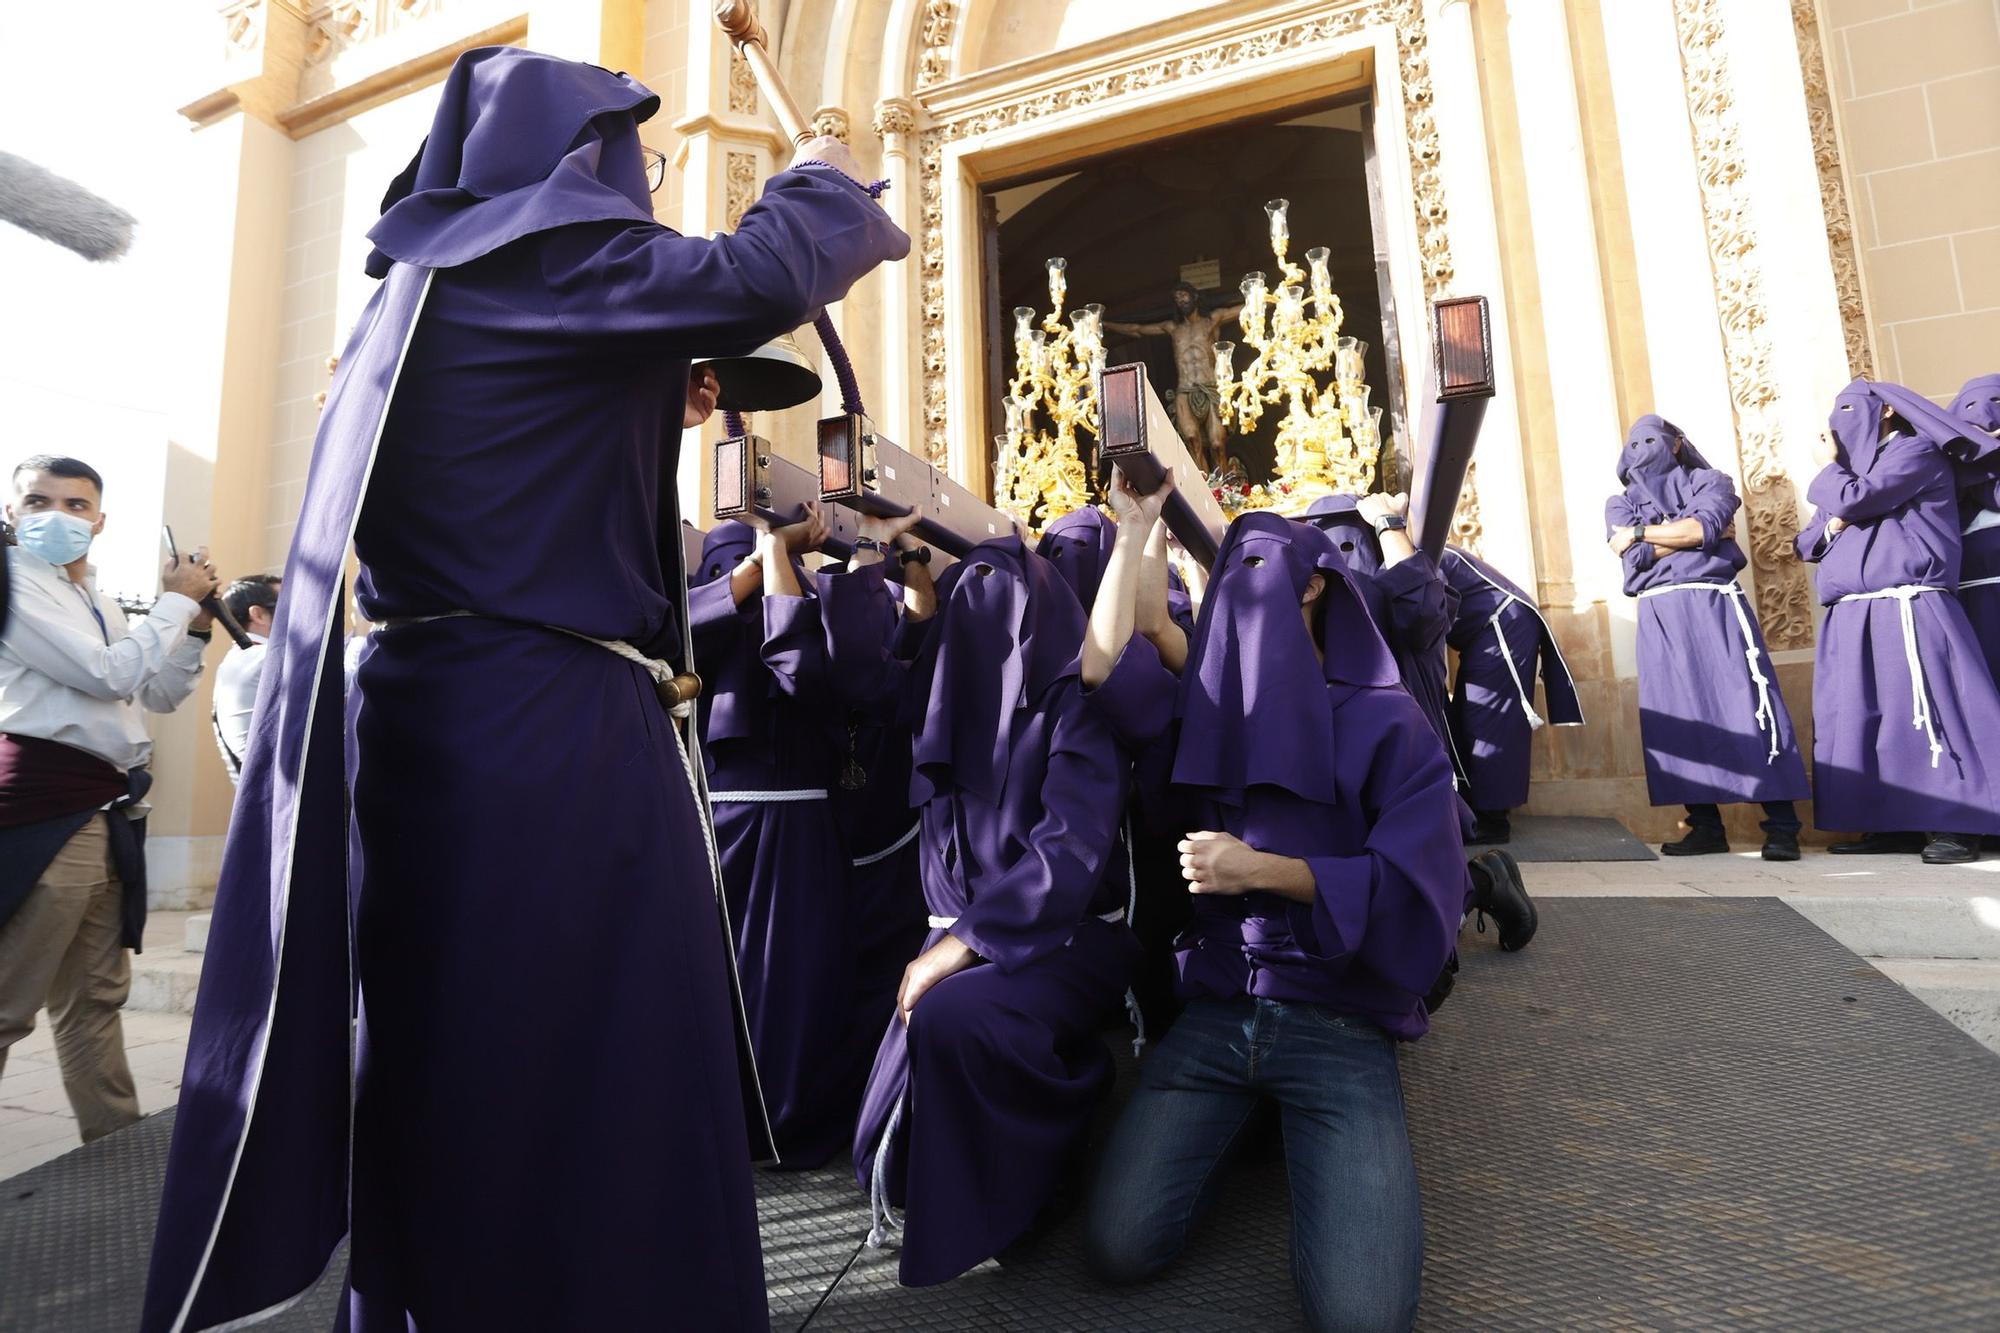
[162,0,2000,868]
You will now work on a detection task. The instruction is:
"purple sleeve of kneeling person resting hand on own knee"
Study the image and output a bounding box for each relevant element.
[952,691,1128,973]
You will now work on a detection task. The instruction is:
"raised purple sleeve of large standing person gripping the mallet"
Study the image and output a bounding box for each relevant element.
[542,170,910,356]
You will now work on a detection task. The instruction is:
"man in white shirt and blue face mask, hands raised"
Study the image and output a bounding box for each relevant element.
[0,454,216,1143]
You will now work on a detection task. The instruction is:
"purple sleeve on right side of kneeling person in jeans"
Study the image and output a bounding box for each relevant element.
[1290,691,1466,995]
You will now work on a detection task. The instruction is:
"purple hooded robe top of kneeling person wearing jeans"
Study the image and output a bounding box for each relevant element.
[1094,512,1466,1041]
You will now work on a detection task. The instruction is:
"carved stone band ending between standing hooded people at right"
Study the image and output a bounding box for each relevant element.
[1674,0,1812,648]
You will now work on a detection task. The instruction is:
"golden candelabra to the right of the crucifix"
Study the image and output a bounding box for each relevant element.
[1216,198,1382,508]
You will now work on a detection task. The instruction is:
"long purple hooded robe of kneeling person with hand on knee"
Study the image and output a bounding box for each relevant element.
[820,538,1138,1287]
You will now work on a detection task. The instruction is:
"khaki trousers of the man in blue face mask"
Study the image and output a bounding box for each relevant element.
[0,815,138,1143]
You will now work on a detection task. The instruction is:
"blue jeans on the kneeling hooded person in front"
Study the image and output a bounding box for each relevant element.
[1084,997,1424,1329]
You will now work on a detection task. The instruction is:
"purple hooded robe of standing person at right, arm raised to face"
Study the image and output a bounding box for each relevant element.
[1798,380,2000,835]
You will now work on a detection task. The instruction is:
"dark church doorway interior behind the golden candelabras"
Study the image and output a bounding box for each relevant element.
[982,94,1410,506]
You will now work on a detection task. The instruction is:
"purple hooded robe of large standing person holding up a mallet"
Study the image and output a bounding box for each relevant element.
[142,48,908,1329]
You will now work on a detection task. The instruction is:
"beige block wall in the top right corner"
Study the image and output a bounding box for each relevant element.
[1822,0,2000,398]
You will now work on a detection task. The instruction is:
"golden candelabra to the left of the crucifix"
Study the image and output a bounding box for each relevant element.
[994,258,1104,528]
